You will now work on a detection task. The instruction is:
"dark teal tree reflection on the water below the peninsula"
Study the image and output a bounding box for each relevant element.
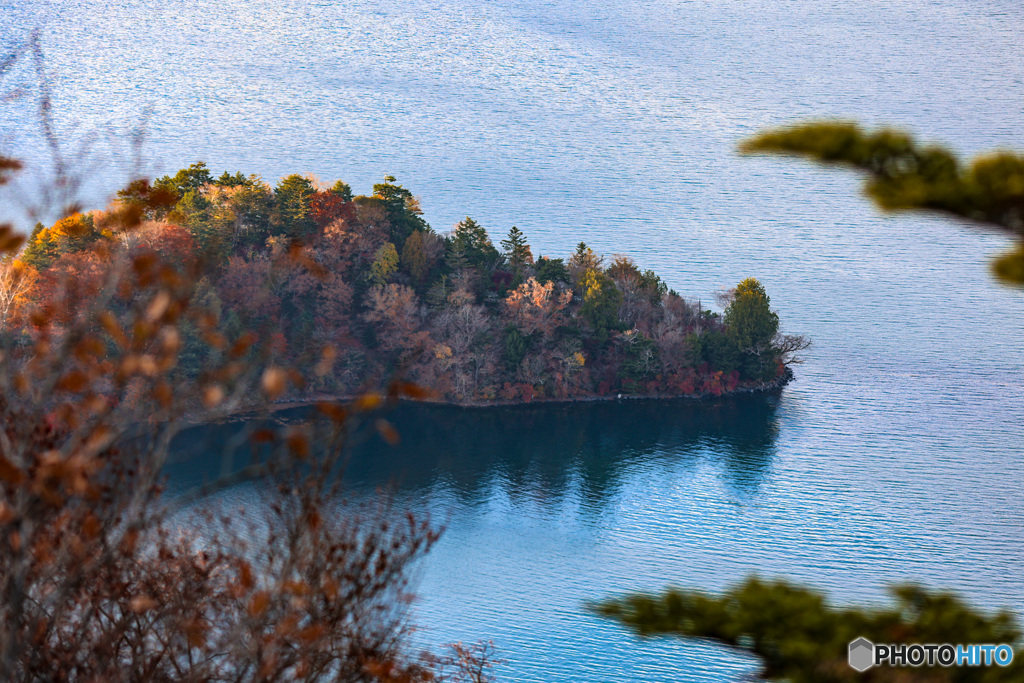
[168,394,778,505]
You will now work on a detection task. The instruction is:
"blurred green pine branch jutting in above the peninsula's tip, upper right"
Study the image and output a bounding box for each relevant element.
[740,122,1024,285]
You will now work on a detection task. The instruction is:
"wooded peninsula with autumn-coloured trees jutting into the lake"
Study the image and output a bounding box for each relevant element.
[6,163,808,403]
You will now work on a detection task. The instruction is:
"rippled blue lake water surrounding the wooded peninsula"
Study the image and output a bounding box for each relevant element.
[0,0,1024,682]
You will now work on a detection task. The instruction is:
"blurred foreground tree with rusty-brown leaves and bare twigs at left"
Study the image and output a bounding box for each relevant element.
[0,152,489,683]
